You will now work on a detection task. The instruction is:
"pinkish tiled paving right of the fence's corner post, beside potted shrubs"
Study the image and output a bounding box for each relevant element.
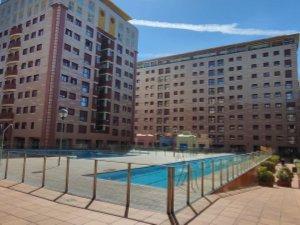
[190,187,300,225]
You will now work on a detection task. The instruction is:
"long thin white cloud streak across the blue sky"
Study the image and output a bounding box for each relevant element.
[130,19,299,36]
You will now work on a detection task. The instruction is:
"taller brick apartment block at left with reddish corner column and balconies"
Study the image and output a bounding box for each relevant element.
[0,0,138,148]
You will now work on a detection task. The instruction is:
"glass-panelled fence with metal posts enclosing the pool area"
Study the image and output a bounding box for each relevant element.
[0,151,269,217]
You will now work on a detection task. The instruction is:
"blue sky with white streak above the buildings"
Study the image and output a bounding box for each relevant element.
[113,0,300,77]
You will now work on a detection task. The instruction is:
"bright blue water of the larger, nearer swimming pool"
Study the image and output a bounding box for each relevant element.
[98,156,237,188]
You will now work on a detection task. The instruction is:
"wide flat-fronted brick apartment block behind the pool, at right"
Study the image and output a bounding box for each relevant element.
[135,34,300,151]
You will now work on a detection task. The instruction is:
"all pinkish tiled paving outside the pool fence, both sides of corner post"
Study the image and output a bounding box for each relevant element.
[0,182,300,225]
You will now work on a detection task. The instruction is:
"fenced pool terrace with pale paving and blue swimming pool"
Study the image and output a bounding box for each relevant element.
[0,150,269,224]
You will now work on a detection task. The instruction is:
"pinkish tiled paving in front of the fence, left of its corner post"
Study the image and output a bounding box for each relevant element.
[0,187,149,225]
